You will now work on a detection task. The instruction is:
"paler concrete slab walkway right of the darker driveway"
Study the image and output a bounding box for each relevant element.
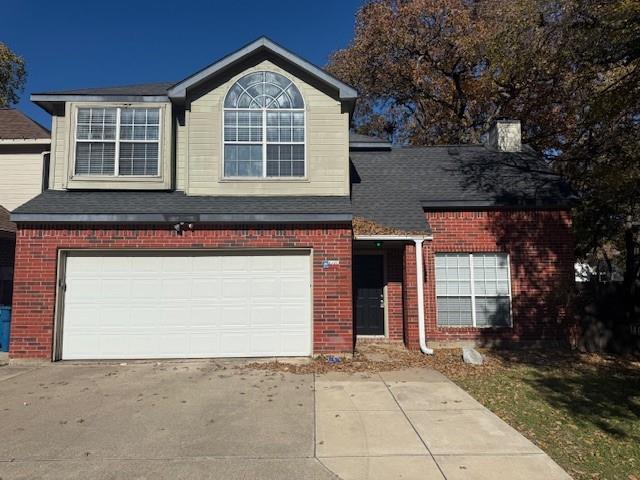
[315,369,571,480]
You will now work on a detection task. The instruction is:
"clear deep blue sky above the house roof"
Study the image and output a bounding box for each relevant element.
[0,0,362,128]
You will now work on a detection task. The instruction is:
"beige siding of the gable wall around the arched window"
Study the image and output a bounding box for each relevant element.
[185,61,349,195]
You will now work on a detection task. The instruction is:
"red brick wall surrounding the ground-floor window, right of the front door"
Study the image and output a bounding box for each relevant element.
[405,211,574,349]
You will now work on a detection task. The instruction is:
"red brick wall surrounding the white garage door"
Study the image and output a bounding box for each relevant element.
[10,225,353,359]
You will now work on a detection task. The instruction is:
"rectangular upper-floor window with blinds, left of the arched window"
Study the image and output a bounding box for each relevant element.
[75,107,160,176]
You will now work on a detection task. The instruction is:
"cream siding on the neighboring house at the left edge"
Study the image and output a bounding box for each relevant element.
[0,149,44,211]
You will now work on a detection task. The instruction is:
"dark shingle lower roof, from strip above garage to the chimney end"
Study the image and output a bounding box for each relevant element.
[13,145,574,233]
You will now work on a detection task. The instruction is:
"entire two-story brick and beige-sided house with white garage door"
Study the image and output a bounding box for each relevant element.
[10,38,573,360]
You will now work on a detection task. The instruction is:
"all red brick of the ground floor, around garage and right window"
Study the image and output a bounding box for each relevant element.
[11,211,574,358]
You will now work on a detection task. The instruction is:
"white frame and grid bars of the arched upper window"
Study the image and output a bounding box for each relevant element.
[222,70,308,180]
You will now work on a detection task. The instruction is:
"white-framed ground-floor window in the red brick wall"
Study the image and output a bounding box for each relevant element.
[435,253,511,327]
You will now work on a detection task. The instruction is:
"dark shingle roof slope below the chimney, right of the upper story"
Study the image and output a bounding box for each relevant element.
[350,145,574,233]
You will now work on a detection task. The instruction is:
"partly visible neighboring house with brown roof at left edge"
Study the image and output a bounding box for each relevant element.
[0,108,51,305]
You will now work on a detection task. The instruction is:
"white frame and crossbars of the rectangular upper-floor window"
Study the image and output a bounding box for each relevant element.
[71,105,163,179]
